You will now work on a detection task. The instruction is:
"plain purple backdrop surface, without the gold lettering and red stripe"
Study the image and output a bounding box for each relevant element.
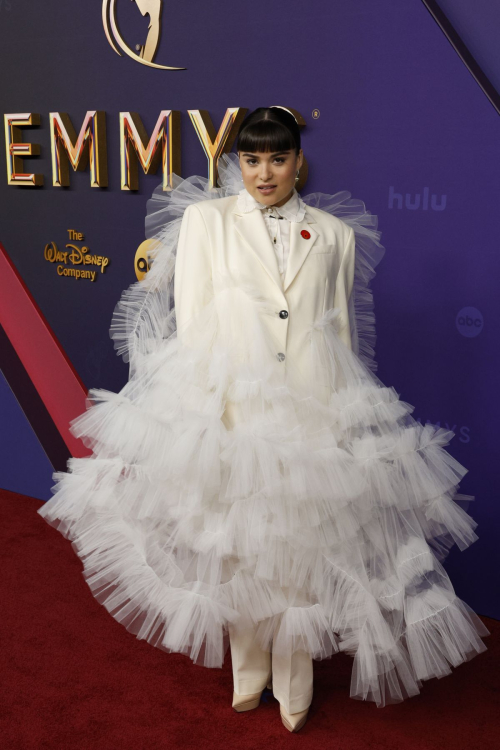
[0,0,500,616]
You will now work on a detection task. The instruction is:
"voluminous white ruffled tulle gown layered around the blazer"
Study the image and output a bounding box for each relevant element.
[39,154,489,706]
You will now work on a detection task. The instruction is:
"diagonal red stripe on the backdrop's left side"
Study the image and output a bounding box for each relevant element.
[0,242,91,458]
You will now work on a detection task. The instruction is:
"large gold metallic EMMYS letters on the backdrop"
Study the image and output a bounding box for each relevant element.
[4,105,307,191]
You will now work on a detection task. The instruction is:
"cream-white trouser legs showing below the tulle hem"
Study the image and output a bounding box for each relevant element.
[228,623,313,714]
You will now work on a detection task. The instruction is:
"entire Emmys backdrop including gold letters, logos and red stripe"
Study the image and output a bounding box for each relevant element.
[0,0,500,616]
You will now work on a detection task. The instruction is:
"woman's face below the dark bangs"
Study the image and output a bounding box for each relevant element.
[238,149,304,206]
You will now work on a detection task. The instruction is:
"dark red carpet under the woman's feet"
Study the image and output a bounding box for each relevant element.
[0,490,500,750]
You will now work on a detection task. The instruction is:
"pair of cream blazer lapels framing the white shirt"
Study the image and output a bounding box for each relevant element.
[233,197,319,292]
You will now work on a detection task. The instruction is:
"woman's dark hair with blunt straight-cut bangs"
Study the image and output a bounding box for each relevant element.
[236,107,300,155]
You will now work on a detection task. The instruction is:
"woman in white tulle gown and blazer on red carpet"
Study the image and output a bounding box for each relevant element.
[39,107,489,731]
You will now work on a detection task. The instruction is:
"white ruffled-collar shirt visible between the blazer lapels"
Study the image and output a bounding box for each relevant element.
[238,188,306,280]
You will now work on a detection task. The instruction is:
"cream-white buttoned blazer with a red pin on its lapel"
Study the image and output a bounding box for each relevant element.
[174,195,355,424]
